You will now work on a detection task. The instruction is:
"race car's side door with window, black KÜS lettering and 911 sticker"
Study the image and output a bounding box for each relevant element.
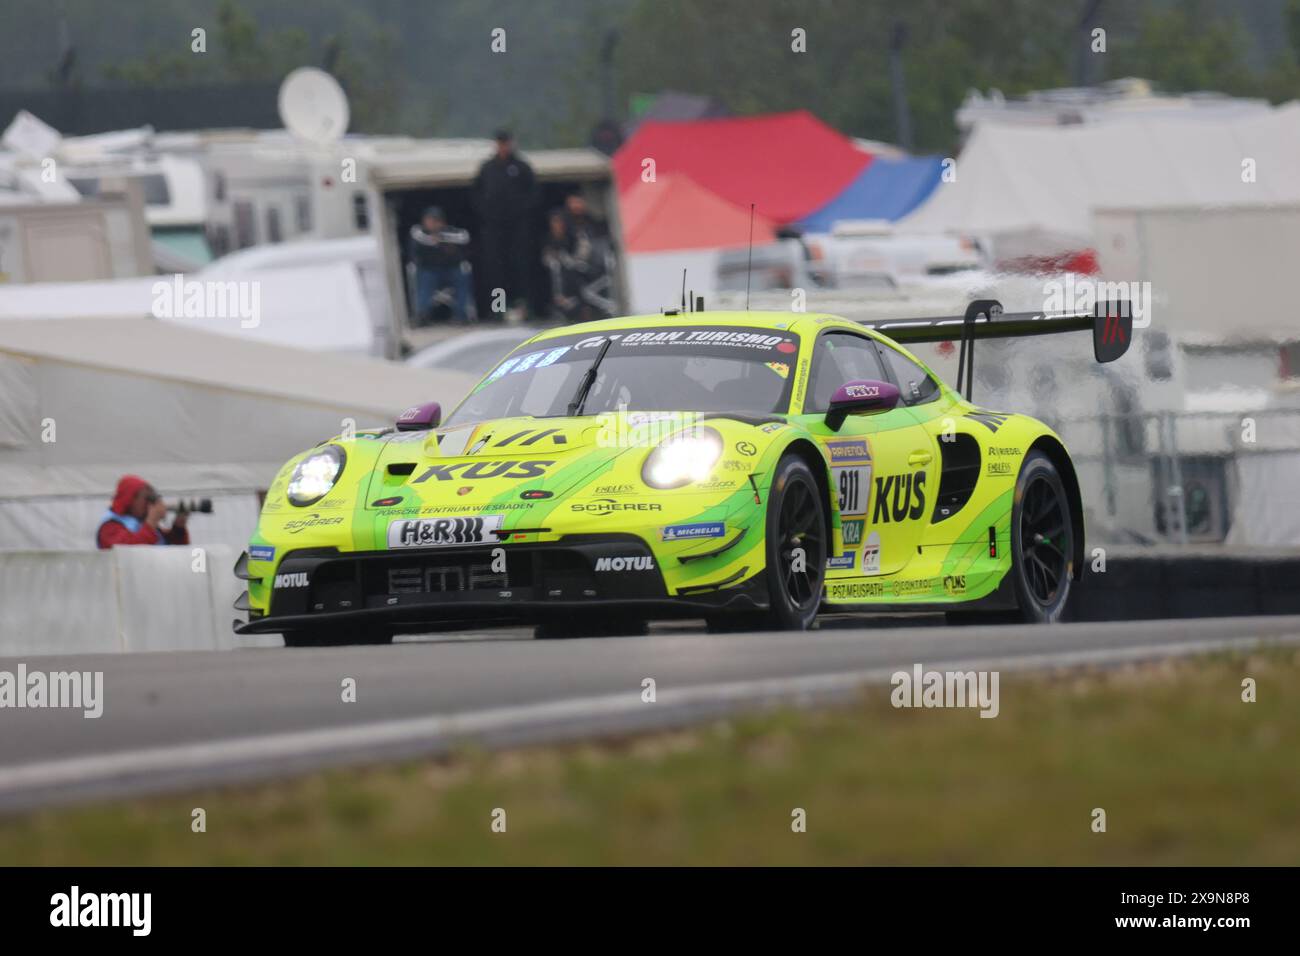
[800,329,936,578]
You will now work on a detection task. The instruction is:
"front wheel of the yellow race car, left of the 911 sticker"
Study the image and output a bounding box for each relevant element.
[754,455,827,631]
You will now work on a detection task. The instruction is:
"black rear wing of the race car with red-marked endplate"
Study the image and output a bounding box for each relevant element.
[862,299,1134,401]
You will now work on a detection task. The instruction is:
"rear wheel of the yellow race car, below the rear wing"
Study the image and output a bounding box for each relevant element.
[1009,451,1075,624]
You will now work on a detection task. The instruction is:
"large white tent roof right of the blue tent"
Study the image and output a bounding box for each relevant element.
[898,103,1300,245]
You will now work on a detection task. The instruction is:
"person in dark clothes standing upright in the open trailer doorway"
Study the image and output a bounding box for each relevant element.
[475,130,538,321]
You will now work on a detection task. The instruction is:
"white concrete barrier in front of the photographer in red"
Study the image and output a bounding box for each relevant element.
[0,545,241,657]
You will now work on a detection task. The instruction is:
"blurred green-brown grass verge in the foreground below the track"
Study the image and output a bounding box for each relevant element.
[0,649,1300,865]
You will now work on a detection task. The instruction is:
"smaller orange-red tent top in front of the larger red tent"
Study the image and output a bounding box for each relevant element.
[619,176,776,252]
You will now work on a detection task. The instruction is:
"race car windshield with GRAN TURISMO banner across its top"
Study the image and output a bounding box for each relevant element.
[447,325,798,424]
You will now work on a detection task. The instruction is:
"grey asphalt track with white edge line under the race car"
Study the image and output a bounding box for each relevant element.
[0,617,1300,812]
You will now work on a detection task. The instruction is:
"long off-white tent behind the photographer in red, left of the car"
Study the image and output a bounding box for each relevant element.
[0,319,473,549]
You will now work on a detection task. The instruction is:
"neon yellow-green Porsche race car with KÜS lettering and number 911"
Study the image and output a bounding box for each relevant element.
[235,300,1132,645]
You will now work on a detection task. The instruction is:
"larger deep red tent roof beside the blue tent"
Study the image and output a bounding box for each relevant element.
[614,111,871,222]
